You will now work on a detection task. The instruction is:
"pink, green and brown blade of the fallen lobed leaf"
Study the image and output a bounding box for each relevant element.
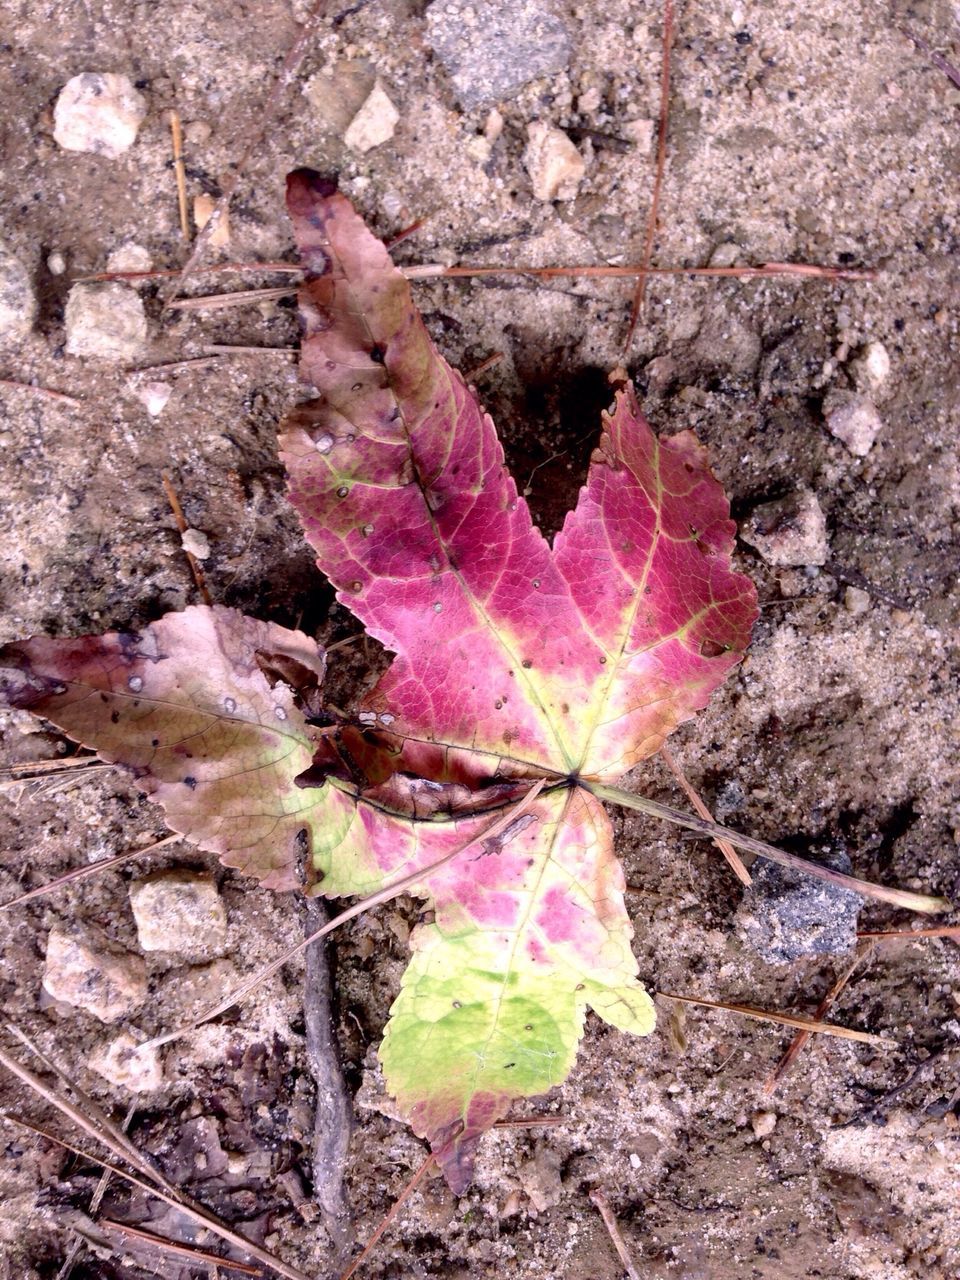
[0,170,942,1192]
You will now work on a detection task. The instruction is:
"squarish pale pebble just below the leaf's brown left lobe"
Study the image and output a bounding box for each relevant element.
[129,869,227,957]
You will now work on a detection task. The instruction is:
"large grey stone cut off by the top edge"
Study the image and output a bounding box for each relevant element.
[426,0,572,111]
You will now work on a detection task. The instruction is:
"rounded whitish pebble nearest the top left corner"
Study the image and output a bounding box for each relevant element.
[54,72,147,160]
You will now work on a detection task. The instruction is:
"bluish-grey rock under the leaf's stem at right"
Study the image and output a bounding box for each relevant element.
[735,846,863,964]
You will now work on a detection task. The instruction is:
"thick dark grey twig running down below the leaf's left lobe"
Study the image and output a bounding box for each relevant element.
[303,897,356,1258]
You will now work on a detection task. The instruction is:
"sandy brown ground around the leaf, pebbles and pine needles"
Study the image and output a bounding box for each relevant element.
[0,0,960,1280]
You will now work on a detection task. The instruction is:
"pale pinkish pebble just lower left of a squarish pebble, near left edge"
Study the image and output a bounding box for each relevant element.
[44,924,147,1023]
